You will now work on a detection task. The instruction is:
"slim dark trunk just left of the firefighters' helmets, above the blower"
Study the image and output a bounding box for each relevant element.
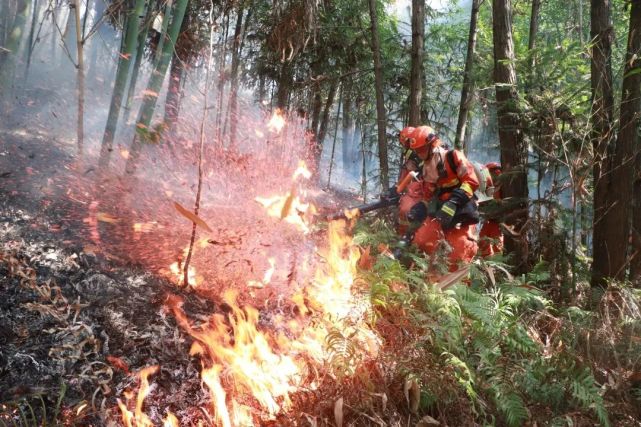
[369,0,389,190]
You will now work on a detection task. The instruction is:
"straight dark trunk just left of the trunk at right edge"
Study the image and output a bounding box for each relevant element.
[590,0,616,286]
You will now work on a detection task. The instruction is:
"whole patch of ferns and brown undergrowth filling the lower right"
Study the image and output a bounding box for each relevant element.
[355,222,641,426]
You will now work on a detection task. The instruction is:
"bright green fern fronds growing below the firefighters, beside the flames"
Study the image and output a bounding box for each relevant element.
[357,224,616,426]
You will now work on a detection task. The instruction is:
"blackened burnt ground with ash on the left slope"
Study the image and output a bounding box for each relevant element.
[0,131,362,425]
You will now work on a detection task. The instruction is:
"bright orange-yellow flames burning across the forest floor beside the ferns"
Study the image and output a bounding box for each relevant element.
[119,163,379,427]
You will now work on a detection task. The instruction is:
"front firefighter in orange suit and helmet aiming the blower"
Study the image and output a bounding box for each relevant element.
[400,126,479,271]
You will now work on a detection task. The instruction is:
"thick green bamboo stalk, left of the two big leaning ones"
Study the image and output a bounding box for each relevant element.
[99,0,145,168]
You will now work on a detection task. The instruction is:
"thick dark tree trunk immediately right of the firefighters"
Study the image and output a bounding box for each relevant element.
[492,0,528,273]
